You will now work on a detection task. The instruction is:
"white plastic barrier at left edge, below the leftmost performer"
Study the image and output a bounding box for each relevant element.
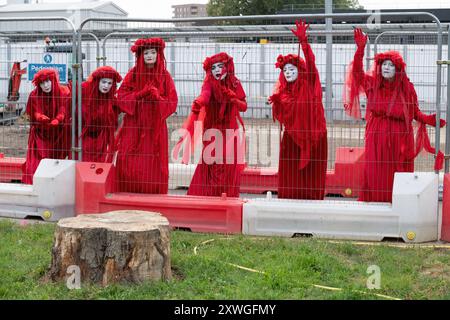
[0,159,75,221]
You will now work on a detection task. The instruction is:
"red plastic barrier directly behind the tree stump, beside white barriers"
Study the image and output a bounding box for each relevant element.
[76,163,244,233]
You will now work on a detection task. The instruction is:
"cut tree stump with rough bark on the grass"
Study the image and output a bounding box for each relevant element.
[48,210,172,286]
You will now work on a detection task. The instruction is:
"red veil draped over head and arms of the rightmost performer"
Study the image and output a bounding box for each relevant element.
[343,51,444,170]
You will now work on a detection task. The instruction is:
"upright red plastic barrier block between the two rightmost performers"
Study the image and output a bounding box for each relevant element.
[325,147,364,197]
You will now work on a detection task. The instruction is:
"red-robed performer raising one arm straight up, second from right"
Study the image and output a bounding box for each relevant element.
[269,21,328,200]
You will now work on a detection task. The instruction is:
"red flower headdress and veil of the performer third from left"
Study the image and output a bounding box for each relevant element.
[131,38,166,90]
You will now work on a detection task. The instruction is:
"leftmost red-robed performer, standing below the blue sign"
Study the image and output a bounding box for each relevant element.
[22,69,70,184]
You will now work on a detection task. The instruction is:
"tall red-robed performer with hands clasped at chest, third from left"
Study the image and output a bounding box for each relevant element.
[117,38,178,193]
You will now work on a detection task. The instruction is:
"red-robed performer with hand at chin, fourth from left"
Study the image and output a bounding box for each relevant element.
[174,52,247,197]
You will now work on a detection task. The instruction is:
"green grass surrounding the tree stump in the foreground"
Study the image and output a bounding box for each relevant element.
[0,220,450,299]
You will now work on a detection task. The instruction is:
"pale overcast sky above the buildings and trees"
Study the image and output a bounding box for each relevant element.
[0,0,450,19]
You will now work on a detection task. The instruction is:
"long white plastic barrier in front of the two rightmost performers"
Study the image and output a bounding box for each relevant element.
[242,172,438,242]
